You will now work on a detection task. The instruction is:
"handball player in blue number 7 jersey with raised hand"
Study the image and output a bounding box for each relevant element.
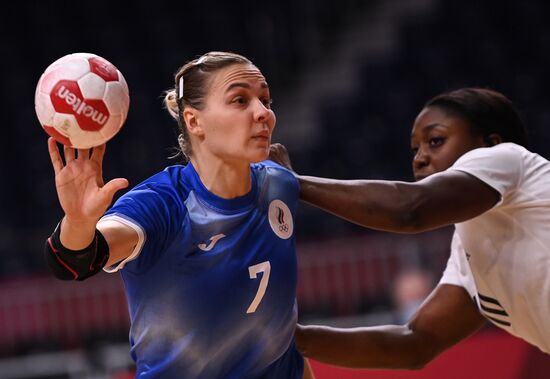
[45,52,312,379]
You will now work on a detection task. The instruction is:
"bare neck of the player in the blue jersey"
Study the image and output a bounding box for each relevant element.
[191,155,252,199]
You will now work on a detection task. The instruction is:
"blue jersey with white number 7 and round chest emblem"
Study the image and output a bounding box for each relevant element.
[103,161,303,379]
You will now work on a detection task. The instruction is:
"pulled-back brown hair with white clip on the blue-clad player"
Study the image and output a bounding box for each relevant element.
[164,51,252,158]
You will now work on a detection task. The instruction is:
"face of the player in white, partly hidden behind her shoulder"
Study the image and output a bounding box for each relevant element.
[411,107,485,180]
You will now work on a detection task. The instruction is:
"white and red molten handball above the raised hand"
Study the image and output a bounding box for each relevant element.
[34,53,130,149]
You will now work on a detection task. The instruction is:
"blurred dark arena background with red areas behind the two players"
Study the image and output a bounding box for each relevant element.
[0,0,550,379]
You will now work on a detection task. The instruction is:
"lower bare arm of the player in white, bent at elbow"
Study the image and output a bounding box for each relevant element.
[296,284,485,369]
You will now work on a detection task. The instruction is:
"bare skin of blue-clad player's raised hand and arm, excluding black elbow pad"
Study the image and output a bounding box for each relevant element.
[48,138,138,265]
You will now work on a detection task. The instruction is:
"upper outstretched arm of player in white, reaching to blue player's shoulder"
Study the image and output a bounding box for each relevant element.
[298,171,500,233]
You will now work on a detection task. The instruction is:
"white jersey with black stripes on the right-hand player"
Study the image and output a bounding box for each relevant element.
[440,143,550,354]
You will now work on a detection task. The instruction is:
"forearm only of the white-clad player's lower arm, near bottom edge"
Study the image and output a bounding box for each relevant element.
[296,325,437,369]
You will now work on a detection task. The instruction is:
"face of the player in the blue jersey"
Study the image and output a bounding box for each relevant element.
[200,64,275,163]
